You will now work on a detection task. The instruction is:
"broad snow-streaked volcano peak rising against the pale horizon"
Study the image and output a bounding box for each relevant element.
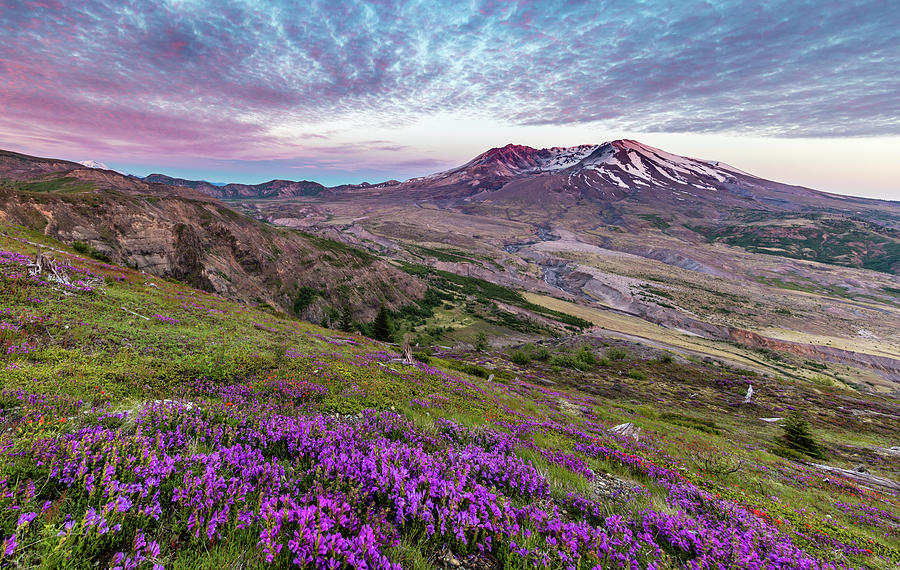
[373,139,845,209]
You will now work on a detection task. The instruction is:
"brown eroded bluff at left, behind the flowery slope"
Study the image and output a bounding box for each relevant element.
[0,148,425,321]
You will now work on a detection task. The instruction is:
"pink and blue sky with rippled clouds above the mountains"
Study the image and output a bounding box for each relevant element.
[0,0,900,200]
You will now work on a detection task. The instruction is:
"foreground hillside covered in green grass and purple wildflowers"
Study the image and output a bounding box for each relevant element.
[0,221,900,568]
